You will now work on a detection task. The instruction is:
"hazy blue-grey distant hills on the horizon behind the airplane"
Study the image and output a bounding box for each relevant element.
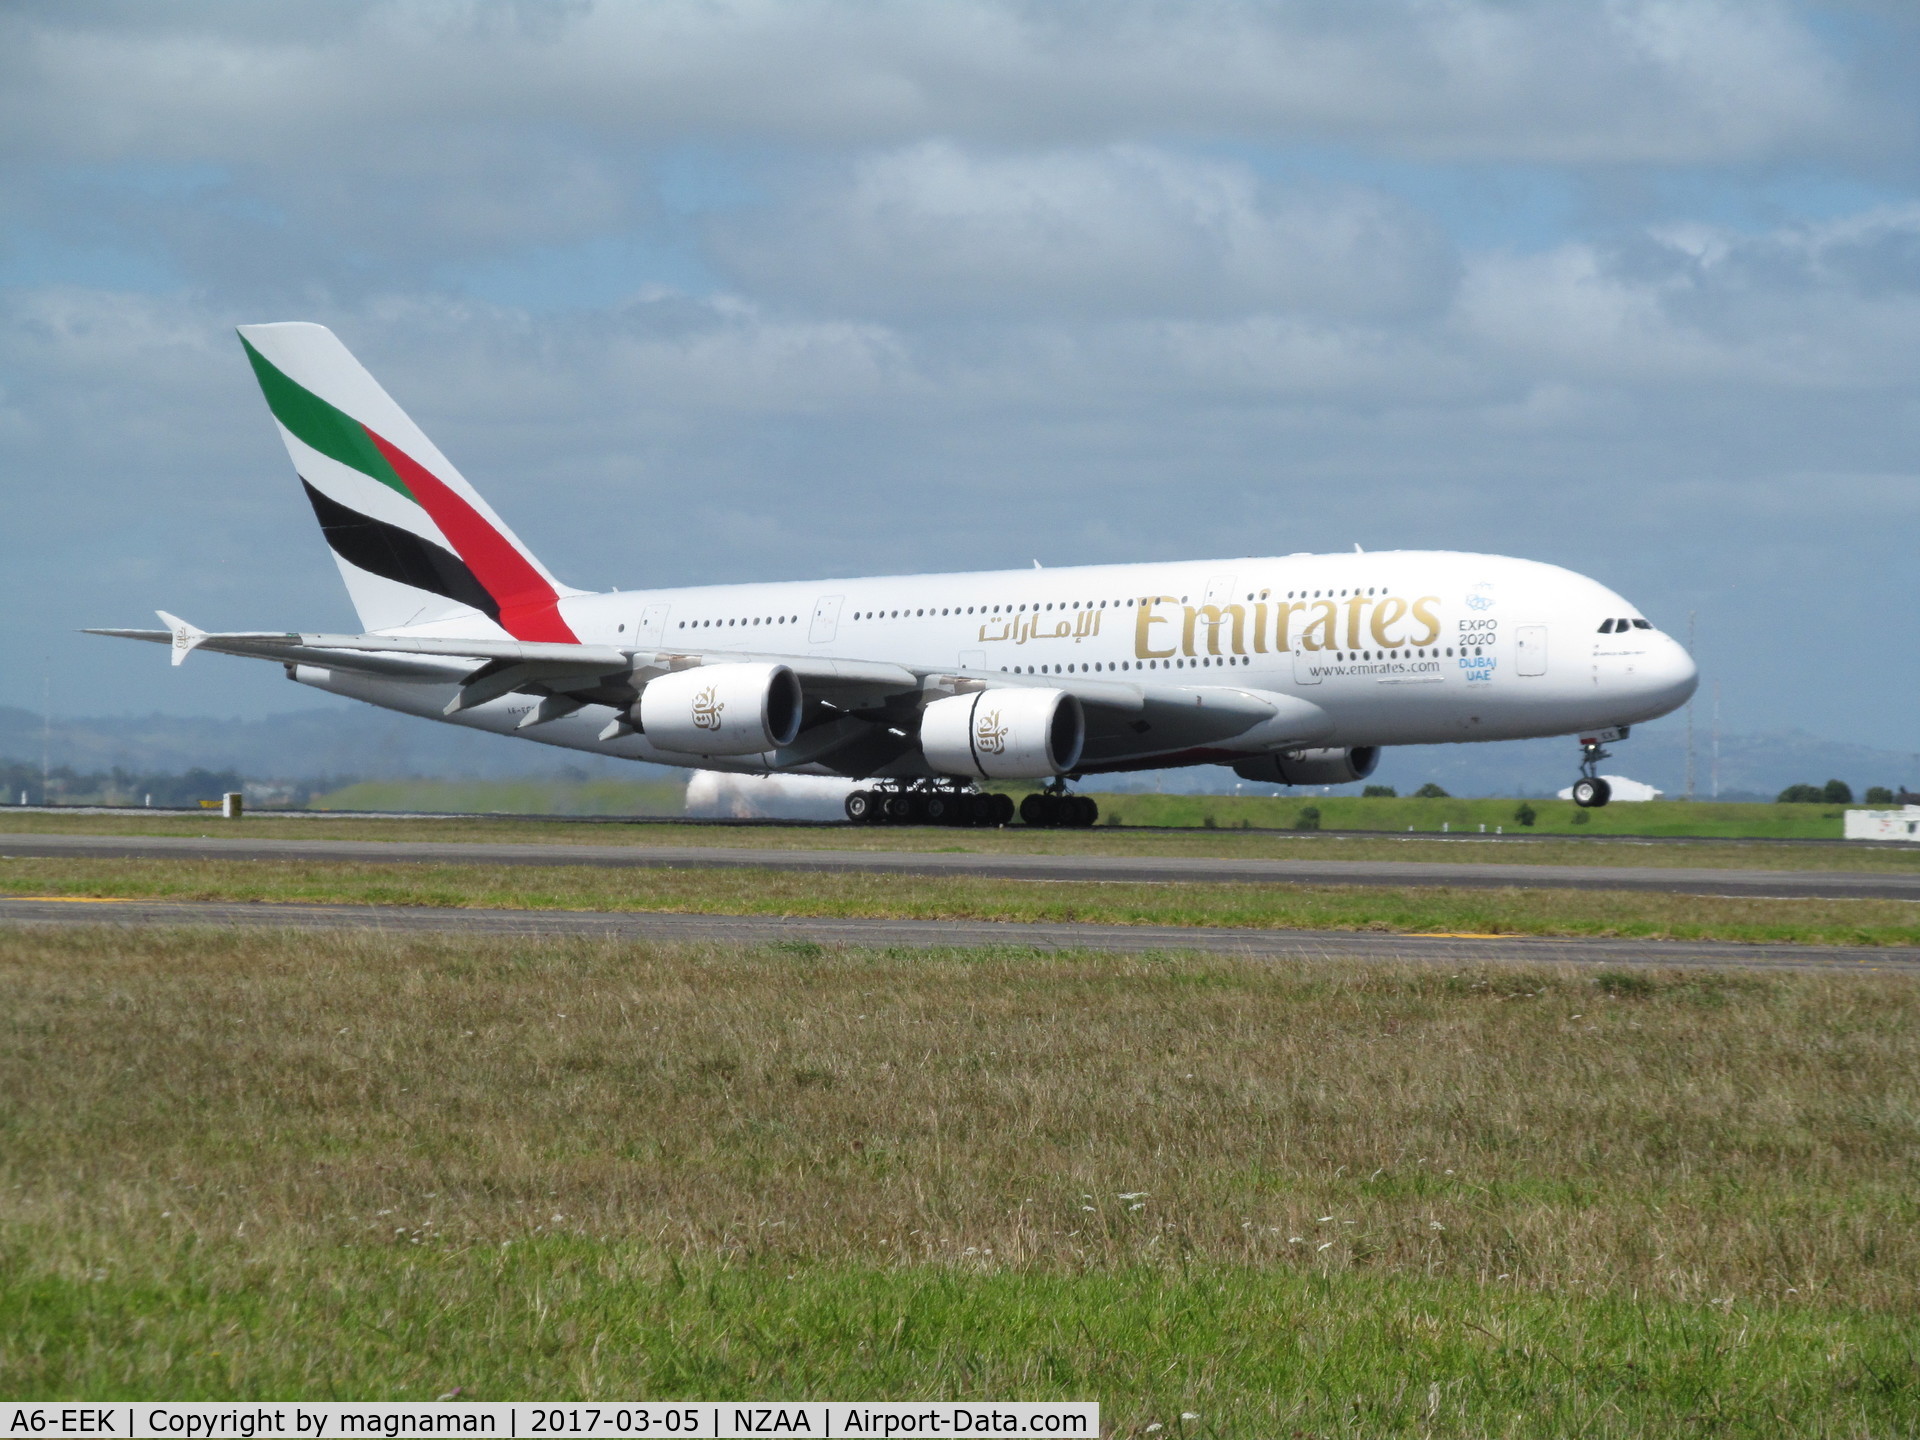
[0,707,1920,801]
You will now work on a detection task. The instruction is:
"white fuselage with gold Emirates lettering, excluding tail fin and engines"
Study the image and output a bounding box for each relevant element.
[292,551,1697,772]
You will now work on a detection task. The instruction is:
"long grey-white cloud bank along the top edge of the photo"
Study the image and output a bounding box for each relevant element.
[0,0,1885,171]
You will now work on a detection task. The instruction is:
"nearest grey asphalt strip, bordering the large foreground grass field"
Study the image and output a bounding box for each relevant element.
[0,899,1920,973]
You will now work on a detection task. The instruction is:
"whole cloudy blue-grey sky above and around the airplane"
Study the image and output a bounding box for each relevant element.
[0,0,1920,751]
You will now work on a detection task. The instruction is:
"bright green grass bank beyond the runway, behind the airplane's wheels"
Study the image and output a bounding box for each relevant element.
[295,780,1845,839]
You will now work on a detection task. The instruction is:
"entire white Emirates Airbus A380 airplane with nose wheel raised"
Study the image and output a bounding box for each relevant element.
[92,324,1695,826]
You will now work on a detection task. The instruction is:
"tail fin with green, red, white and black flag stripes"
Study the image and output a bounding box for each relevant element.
[240,323,580,643]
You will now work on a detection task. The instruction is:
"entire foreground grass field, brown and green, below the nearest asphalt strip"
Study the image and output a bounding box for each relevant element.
[0,929,1920,1436]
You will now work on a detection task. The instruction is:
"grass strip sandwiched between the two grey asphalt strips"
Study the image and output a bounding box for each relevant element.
[0,856,1920,947]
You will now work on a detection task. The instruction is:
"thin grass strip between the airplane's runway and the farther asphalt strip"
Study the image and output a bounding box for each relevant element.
[0,814,1920,874]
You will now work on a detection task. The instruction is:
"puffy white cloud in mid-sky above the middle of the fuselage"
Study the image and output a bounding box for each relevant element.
[718,140,1453,315]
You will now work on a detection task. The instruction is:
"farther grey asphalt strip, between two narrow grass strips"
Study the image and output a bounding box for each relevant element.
[0,831,1920,900]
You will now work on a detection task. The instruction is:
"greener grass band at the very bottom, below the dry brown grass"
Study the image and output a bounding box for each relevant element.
[0,1236,1920,1436]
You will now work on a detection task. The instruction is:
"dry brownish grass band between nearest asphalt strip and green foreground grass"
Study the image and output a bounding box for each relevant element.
[0,929,1920,1308]
